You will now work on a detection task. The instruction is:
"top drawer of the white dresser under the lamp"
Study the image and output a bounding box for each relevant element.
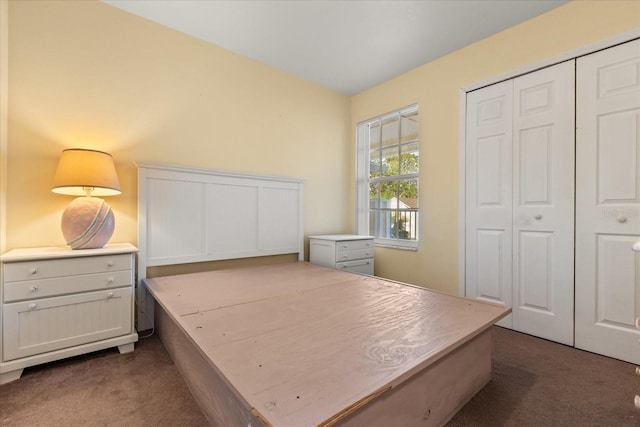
[4,254,131,285]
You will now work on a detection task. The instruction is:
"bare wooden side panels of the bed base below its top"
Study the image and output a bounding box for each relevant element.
[155,304,492,427]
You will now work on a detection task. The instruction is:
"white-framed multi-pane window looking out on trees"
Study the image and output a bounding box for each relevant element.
[356,105,420,249]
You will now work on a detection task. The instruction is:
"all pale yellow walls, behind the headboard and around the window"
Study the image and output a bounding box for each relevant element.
[5,0,640,293]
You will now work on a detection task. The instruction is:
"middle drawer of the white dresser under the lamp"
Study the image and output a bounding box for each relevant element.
[4,270,133,302]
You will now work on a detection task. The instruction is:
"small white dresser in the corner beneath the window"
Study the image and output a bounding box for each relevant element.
[309,234,374,275]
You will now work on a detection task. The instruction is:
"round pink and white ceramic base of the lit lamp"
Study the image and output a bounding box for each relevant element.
[62,197,115,249]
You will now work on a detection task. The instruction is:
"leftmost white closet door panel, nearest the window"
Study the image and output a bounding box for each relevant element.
[465,81,513,327]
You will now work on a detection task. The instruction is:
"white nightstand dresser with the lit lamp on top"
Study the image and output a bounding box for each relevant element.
[0,243,138,384]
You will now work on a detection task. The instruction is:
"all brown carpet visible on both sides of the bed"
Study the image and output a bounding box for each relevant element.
[0,327,640,427]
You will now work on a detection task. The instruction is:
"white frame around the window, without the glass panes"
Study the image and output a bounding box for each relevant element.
[356,104,421,251]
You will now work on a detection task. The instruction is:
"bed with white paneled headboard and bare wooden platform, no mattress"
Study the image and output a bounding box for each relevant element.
[138,164,509,427]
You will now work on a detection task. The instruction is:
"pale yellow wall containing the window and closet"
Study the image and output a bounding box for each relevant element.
[351,1,640,293]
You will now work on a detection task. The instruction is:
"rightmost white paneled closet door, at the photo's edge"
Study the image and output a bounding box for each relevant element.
[575,40,640,364]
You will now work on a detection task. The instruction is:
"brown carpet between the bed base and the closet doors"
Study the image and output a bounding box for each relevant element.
[447,326,640,427]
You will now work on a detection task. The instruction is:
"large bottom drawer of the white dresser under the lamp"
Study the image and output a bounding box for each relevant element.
[2,287,133,361]
